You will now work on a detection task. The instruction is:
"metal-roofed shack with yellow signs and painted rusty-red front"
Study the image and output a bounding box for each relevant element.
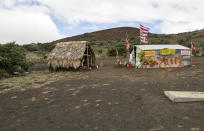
[129,45,192,68]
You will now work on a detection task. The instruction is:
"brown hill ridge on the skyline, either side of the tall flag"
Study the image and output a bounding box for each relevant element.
[54,27,204,46]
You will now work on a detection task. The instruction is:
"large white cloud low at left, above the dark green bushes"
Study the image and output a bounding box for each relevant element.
[0,0,63,44]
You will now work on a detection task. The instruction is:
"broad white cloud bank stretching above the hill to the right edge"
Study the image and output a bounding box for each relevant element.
[35,0,204,33]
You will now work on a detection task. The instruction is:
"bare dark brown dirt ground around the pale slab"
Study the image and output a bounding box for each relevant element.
[0,58,204,131]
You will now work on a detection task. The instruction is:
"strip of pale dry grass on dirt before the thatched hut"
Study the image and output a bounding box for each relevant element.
[0,71,83,93]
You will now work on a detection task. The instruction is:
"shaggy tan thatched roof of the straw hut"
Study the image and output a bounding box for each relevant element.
[48,41,92,69]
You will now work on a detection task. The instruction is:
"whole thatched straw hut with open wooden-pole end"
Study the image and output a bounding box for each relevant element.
[48,41,95,70]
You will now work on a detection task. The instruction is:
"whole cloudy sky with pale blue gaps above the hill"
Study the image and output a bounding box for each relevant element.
[0,0,204,45]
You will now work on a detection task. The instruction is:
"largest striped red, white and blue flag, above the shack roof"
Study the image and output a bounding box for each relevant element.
[140,24,150,44]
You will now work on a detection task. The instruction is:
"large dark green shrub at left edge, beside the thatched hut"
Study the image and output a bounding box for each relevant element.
[0,42,30,76]
